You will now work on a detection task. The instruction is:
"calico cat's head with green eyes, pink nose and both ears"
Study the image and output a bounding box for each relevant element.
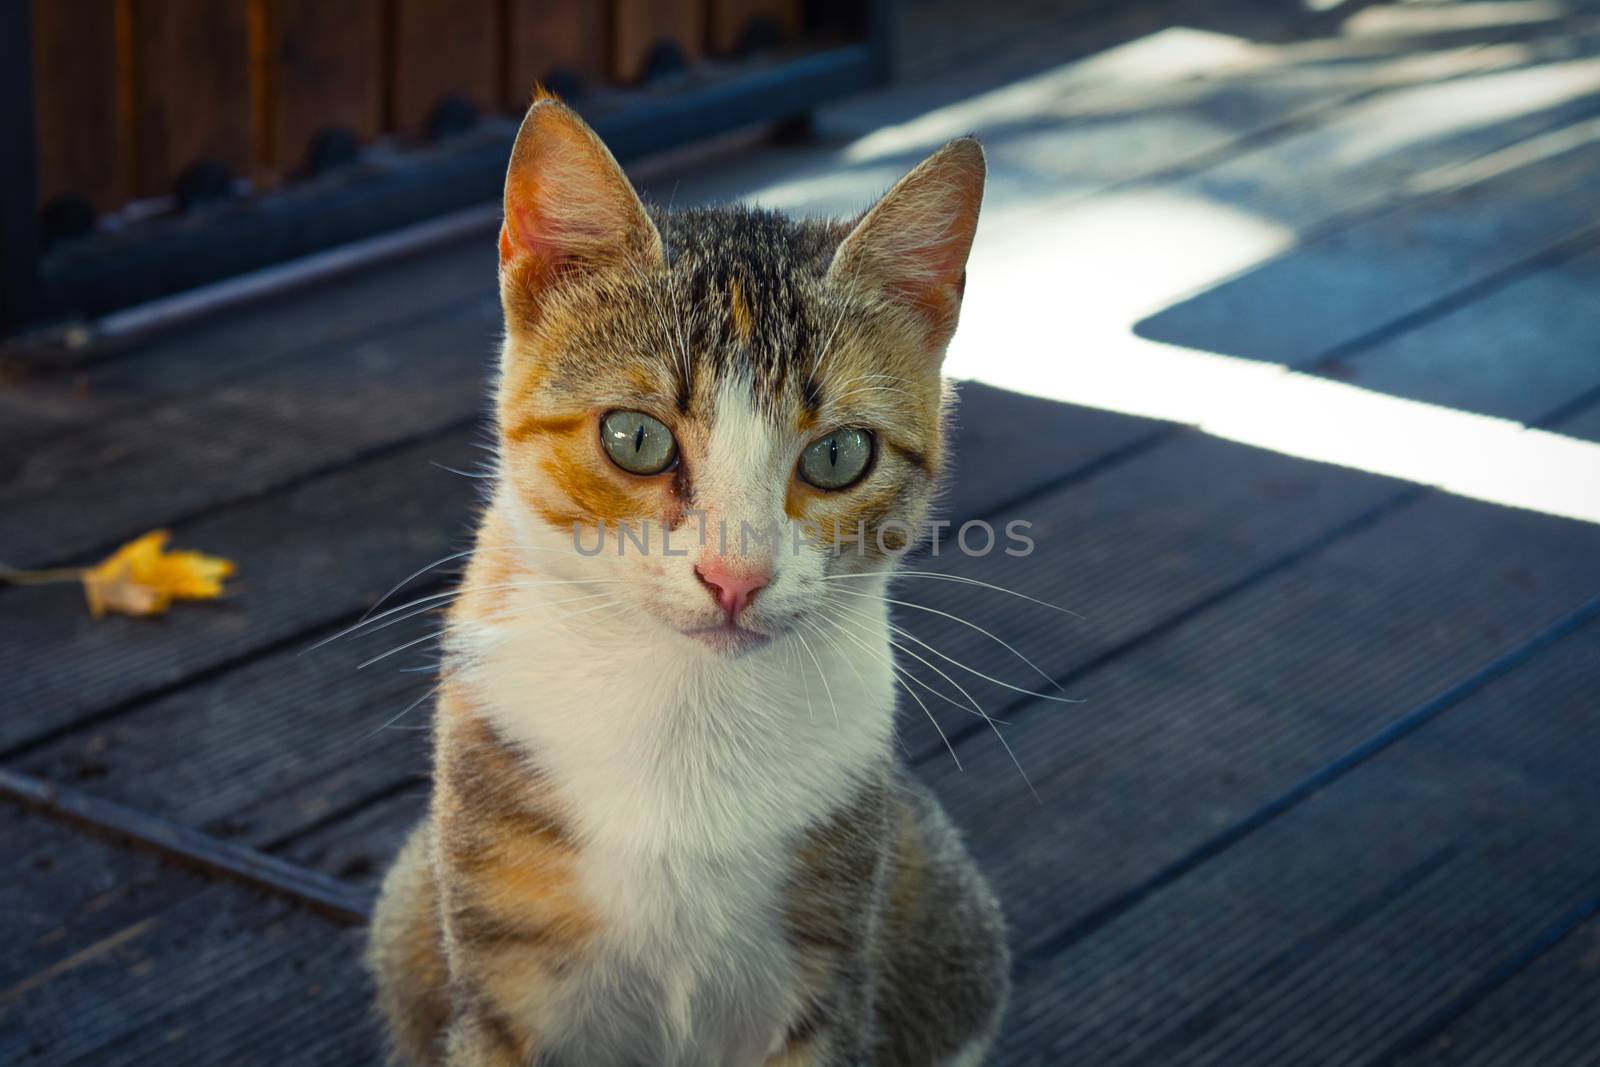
[496,101,984,653]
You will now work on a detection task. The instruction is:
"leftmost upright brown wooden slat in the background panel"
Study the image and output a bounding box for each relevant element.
[32,0,131,211]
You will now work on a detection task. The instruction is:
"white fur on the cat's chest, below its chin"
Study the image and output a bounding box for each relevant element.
[454,579,893,1067]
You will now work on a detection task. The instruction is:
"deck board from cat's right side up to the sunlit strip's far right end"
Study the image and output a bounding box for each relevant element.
[923,496,1600,958]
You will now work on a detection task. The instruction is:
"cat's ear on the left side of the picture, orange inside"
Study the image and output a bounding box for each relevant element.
[499,99,666,299]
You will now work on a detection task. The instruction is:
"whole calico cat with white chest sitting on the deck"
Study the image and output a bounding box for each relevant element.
[368,101,1008,1067]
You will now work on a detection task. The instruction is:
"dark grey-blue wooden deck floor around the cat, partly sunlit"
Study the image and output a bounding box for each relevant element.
[0,0,1600,1067]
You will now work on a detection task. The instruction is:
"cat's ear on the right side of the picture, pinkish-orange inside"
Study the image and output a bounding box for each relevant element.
[827,138,986,354]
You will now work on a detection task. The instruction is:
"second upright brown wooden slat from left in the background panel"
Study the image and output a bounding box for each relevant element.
[131,0,253,197]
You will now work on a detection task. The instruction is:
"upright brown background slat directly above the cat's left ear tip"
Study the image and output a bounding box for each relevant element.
[501,0,606,103]
